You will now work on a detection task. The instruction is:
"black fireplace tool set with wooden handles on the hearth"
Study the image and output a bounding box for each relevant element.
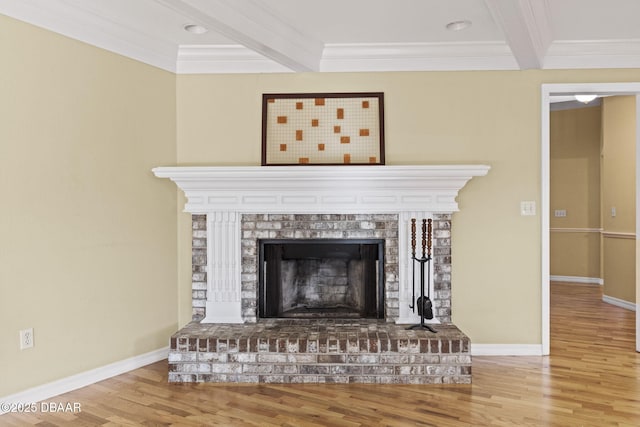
[407,218,437,333]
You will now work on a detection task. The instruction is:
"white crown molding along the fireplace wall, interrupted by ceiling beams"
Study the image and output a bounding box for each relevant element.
[176,39,640,74]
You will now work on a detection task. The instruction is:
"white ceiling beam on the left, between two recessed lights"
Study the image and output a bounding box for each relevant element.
[156,0,324,71]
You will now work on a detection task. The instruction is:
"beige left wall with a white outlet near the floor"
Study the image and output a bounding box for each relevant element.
[0,16,178,396]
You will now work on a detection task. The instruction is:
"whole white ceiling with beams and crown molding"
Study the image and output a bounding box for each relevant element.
[0,0,640,74]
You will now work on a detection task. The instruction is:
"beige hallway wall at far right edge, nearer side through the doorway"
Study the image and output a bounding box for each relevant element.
[602,96,636,303]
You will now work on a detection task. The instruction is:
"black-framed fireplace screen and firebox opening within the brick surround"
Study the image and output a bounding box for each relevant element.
[258,239,384,319]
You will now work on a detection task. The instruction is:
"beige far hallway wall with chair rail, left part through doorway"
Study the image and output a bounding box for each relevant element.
[549,106,602,279]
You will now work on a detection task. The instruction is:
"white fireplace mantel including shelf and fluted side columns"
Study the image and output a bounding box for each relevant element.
[153,165,490,323]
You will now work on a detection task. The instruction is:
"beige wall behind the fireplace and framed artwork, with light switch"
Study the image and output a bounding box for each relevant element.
[177,70,638,344]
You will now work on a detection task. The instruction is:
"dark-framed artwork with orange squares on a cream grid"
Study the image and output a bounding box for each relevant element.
[262,92,384,166]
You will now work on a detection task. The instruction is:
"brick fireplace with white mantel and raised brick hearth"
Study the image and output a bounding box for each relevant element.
[154,165,489,383]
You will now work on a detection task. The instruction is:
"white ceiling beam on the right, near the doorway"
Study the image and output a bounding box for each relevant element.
[484,0,553,70]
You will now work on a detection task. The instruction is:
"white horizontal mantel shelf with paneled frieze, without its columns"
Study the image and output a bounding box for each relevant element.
[153,165,490,214]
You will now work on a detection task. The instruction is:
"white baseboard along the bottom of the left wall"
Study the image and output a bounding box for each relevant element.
[0,347,169,415]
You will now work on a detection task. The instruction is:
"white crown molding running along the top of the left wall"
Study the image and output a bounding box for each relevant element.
[0,0,177,73]
